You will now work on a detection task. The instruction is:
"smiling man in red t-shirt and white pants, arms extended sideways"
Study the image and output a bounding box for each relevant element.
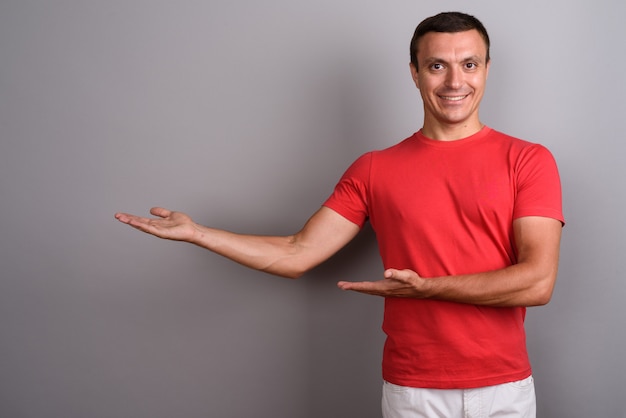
[116,12,563,417]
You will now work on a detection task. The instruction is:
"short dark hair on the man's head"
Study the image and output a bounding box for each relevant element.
[411,12,490,68]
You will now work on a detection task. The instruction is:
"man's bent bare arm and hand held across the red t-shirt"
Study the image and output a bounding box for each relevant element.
[337,216,562,306]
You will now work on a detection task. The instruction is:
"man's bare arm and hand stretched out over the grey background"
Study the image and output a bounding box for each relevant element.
[115,207,360,278]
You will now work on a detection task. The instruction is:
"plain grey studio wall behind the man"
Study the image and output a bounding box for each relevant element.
[0,0,626,418]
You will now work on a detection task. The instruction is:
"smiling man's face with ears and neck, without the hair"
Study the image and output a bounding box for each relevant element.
[411,30,489,135]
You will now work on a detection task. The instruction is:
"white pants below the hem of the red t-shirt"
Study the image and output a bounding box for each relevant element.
[382,376,537,418]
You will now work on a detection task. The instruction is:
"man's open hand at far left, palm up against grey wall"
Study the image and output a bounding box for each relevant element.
[115,208,197,242]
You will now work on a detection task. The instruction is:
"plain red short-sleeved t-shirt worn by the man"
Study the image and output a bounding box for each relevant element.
[324,127,563,388]
